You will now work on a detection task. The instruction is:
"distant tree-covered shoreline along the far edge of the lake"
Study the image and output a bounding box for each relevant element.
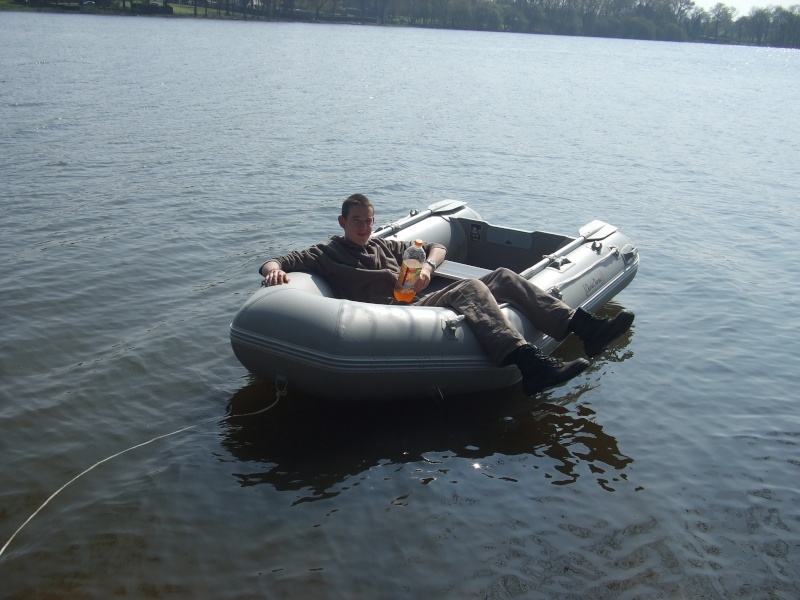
[0,0,800,48]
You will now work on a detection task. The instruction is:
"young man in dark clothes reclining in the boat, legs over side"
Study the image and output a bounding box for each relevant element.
[259,194,634,396]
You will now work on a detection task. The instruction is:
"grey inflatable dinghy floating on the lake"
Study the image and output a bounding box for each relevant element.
[230,200,639,401]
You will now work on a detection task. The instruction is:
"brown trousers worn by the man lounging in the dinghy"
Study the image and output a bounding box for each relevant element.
[415,268,575,365]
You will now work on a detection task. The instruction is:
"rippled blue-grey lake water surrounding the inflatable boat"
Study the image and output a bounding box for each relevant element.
[0,13,800,599]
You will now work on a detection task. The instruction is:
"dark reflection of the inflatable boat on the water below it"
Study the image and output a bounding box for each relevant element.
[222,334,633,502]
